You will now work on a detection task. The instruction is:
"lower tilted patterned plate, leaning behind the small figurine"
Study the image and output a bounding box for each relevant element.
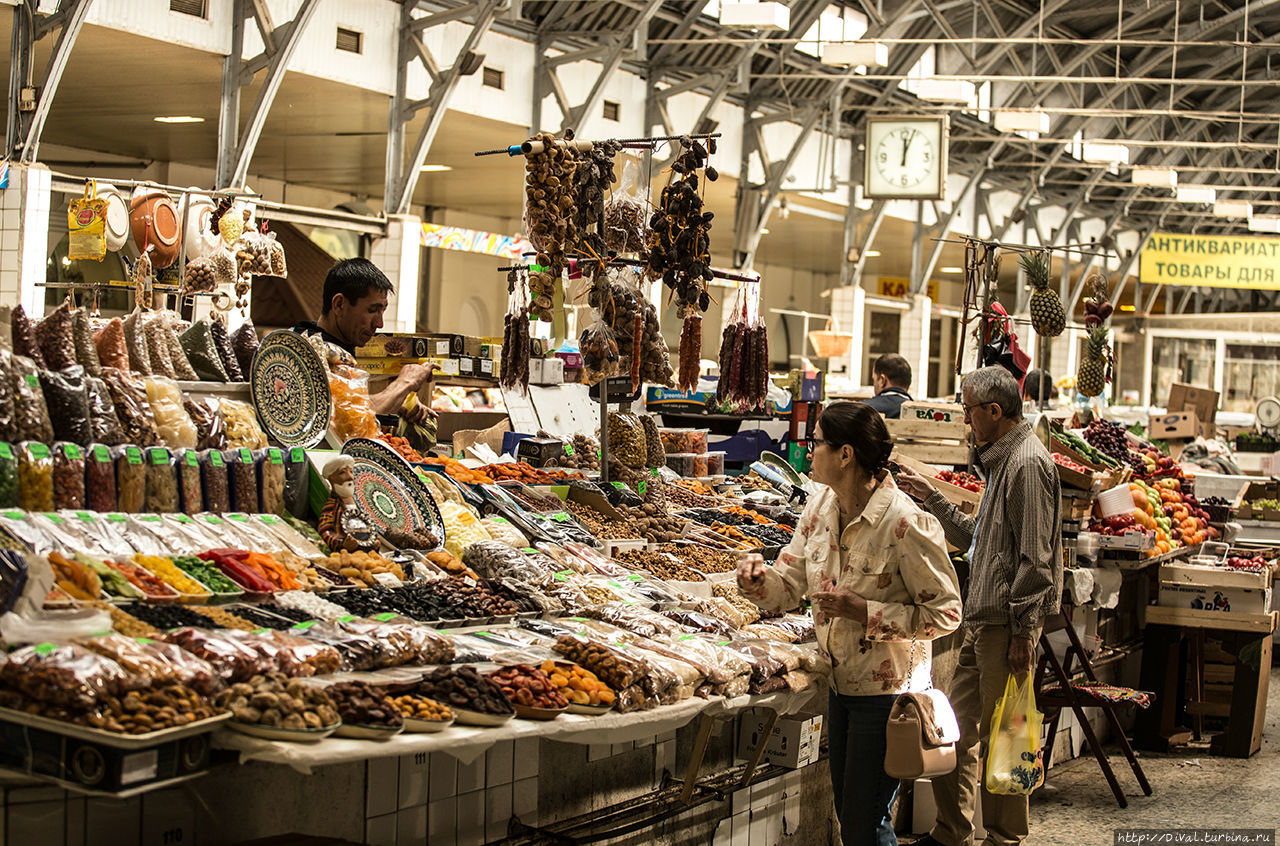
[342,438,444,545]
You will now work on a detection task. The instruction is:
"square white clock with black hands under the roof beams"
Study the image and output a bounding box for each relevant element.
[863,118,947,200]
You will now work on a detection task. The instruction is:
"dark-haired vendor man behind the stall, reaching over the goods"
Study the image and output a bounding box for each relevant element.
[293,252,435,422]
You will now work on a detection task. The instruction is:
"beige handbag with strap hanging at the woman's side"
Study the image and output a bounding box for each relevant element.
[884,644,960,778]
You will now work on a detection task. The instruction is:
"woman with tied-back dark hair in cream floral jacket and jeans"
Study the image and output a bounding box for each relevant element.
[737,402,960,846]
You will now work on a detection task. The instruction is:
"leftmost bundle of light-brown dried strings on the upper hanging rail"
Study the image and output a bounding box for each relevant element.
[525,132,580,323]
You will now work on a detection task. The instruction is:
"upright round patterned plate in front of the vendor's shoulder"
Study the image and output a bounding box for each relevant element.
[248,329,332,448]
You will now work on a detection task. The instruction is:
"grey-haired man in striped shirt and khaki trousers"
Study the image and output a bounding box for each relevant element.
[897,367,1062,846]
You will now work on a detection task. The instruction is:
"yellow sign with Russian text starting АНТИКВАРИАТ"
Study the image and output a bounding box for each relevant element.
[1138,232,1280,291]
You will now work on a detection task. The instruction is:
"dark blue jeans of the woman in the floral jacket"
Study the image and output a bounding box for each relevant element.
[827,691,899,846]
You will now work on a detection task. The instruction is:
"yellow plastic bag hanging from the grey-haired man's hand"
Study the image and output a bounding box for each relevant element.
[987,673,1044,796]
